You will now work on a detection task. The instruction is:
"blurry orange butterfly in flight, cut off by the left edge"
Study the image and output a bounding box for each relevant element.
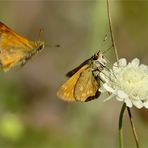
[0,22,44,71]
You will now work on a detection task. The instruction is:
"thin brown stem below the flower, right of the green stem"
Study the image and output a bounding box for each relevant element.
[127,107,139,148]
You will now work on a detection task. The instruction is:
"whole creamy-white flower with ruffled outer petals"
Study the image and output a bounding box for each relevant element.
[101,58,148,108]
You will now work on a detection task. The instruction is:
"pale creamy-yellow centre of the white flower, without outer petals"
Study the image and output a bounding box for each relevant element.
[113,67,148,100]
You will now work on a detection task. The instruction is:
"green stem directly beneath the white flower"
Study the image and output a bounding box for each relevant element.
[118,103,126,148]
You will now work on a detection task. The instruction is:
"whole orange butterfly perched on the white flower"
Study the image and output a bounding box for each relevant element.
[57,51,107,102]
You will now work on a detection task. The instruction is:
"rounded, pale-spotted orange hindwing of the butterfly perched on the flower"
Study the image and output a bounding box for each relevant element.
[75,67,100,102]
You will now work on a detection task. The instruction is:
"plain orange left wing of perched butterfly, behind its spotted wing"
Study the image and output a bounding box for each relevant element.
[57,65,89,101]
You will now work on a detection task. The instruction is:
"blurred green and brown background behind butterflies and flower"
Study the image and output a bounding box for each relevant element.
[0,0,148,148]
